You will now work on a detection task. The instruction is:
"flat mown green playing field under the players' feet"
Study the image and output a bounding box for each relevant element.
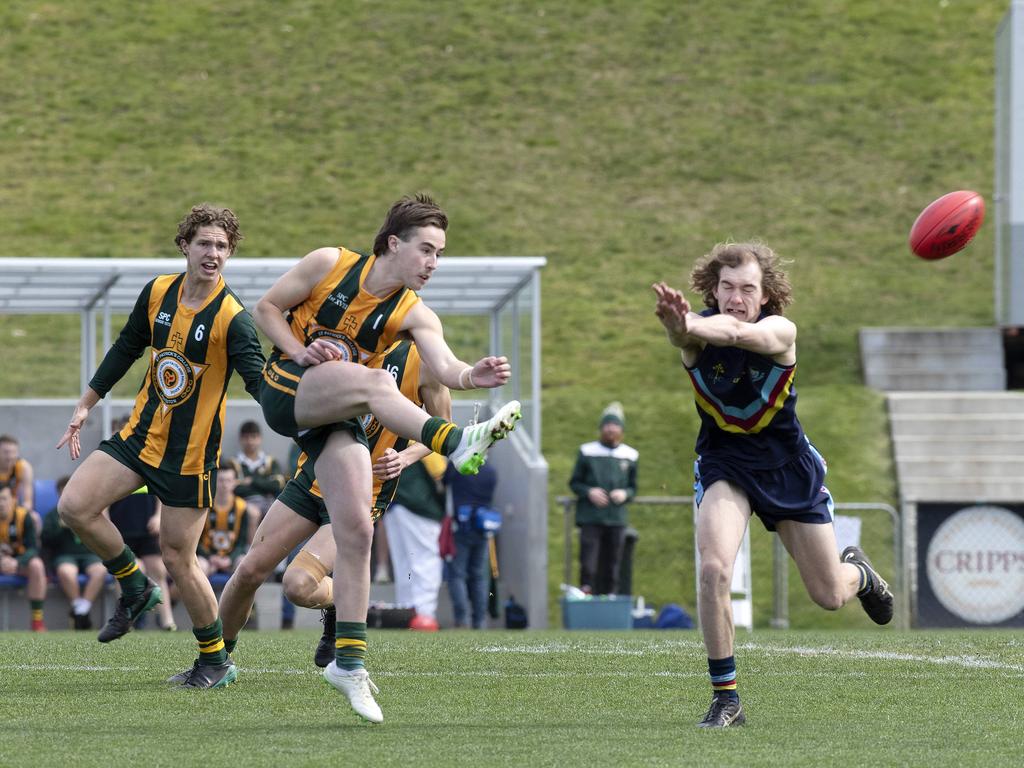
[0,631,1024,768]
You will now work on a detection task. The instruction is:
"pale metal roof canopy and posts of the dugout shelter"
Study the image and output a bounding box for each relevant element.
[0,256,547,455]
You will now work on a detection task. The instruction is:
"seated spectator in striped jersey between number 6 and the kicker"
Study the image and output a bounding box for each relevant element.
[197,462,253,577]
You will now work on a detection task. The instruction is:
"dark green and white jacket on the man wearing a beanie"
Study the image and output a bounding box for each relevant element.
[569,440,640,525]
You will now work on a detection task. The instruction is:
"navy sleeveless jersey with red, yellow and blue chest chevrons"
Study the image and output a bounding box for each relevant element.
[686,310,808,468]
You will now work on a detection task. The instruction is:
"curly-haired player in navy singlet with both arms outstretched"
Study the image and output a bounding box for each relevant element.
[653,243,893,728]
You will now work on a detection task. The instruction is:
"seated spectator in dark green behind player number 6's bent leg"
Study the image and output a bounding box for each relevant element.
[39,477,106,630]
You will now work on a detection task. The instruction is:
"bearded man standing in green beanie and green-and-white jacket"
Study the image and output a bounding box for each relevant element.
[569,402,640,595]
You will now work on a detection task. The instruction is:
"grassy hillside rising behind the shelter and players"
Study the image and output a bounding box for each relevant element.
[0,0,1007,626]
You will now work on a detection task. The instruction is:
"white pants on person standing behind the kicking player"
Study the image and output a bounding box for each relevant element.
[384,504,443,618]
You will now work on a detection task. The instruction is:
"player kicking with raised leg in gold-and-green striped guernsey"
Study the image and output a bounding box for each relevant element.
[248,196,522,724]
